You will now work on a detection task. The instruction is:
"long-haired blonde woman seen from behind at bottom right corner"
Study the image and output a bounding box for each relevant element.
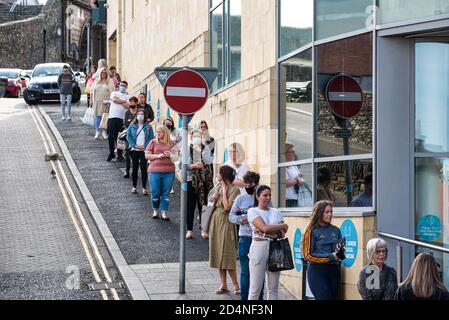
[395,252,449,300]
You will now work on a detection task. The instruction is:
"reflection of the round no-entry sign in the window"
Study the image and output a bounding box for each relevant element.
[325,74,363,120]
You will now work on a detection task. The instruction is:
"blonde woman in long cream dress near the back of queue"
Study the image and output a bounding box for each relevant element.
[92,68,114,139]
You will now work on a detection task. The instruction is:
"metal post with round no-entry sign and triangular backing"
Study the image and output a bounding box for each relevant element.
[154,68,217,294]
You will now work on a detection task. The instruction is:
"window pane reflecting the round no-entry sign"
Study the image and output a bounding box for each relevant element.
[316,33,373,157]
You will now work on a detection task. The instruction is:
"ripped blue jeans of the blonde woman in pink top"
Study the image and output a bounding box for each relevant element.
[150,172,175,211]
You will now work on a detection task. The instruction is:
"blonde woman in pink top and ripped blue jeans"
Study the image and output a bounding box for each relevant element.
[145,126,179,221]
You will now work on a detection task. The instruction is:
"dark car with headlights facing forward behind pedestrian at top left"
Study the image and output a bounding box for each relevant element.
[23,63,81,104]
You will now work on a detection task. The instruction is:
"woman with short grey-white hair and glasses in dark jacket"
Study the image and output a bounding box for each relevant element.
[357,238,398,300]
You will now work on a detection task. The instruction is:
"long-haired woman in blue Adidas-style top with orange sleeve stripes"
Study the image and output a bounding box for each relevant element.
[302,200,345,300]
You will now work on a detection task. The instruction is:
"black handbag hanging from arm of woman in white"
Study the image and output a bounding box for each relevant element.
[268,238,294,272]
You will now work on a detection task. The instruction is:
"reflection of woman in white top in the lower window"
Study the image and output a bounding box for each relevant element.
[285,143,304,208]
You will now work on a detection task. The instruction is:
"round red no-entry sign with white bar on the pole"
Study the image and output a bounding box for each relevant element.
[164,69,209,115]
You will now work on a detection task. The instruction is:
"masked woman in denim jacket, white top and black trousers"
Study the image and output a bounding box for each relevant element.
[127,111,154,195]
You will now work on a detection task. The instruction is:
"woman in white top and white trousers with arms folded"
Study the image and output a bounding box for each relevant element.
[248,185,288,300]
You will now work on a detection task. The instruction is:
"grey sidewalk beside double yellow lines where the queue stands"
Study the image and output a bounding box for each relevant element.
[37,100,296,300]
